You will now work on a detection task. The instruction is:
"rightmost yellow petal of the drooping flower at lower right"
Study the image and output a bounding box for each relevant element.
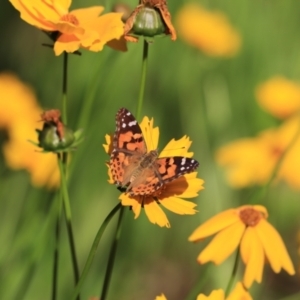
[255,219,295,275]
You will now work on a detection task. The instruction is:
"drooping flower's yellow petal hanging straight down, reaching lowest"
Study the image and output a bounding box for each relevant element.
[240,227,265,288]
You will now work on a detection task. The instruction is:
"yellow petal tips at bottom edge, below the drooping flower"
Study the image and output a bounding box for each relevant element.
[197,282,252,300]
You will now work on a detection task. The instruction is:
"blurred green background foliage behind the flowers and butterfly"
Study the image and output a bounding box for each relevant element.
[0,0,300,300]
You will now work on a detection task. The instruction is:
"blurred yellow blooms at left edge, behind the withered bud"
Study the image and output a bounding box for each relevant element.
[0,73,60,188]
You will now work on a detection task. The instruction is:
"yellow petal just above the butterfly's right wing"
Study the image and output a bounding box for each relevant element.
[159,135,194,157]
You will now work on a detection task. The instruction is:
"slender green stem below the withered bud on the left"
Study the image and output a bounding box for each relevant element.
[58,159,80,300]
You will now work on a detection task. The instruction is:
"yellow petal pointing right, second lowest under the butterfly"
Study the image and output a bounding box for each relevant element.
[160,197,197,215]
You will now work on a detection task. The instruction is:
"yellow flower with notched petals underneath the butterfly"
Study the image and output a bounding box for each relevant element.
[103,113,204,227]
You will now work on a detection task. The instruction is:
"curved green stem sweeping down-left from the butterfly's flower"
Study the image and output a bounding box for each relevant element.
[71,203,121,300]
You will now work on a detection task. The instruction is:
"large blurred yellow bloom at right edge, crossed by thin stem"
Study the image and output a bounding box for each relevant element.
[216,116,300,189]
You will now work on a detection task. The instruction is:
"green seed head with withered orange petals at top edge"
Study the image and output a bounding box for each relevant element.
[124,0,176,42]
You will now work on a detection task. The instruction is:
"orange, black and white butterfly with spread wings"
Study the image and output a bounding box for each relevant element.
[109,108,199,196]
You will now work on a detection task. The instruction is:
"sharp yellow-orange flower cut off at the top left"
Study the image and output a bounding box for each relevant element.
[10,0,124,55]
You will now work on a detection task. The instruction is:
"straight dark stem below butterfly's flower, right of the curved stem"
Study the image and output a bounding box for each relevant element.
[100,206,124,300]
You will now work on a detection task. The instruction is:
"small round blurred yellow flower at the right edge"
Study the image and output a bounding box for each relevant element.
[255,76,300,119]
